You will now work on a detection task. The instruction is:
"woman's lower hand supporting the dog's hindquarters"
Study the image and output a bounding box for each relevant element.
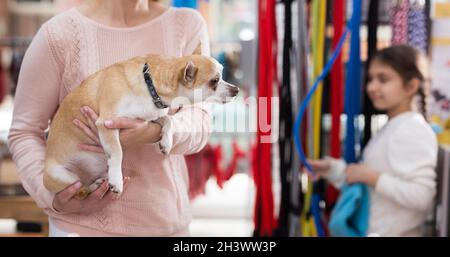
[53,177,130,214]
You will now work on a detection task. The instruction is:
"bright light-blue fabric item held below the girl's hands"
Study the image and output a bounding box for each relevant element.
[328,184,370,237]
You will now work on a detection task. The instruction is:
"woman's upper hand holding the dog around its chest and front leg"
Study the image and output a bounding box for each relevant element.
[73,106,162,153]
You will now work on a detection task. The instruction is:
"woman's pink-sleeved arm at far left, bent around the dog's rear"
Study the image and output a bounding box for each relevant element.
[8,26,61,209]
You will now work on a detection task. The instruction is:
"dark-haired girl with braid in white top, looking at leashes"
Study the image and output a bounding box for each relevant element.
[311,45,438,236]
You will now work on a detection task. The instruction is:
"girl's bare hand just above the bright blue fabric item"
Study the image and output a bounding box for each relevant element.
[345,164,380,188]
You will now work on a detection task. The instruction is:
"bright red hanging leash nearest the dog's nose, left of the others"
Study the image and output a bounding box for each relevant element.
[253,0,277,236]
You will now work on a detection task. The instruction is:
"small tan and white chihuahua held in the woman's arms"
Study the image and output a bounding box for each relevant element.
[44,55,239,199]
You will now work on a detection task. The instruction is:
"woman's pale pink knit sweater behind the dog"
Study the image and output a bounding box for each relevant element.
[9,7,211,236]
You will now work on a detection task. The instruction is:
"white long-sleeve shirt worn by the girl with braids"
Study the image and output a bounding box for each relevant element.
[327,112,438,236]
